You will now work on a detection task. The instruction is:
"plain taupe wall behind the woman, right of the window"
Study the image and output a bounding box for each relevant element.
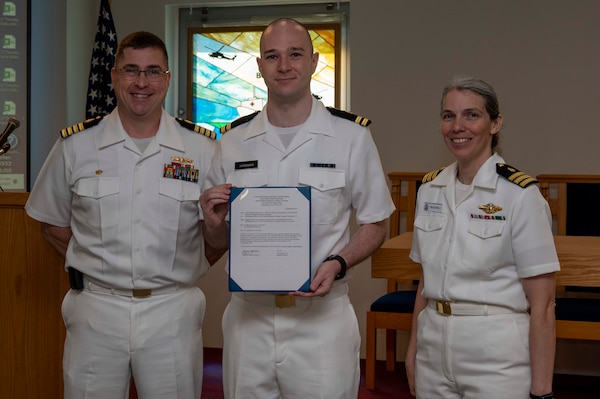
[351,0,600,175]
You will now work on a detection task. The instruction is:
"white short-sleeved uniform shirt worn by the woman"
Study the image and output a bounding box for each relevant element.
[410,154,560,312]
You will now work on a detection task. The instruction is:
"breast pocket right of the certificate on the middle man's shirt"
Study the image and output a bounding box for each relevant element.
[298,169,346,224]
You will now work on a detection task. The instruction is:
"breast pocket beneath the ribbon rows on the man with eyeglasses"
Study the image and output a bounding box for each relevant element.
[158,179,200,231]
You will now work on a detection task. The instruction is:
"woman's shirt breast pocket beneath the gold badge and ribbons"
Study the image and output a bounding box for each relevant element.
[463,220,510,270]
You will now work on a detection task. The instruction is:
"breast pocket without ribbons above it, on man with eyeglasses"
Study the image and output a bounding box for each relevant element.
[72,177,119,229]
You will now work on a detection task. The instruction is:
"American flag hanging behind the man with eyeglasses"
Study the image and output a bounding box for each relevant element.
[85,0,118,119]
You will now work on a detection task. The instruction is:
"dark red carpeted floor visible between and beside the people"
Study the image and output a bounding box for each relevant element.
[202,348,600,399]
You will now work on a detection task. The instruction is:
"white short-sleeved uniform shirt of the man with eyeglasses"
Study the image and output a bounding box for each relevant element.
[25,109,216,289]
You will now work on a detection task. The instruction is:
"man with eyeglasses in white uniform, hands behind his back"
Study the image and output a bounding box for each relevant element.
[26,32,217,399]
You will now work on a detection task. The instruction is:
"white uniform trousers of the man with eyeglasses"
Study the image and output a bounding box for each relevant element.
[62,287,206,399]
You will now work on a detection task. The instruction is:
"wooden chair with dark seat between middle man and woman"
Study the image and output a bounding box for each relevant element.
[365,172,425,389]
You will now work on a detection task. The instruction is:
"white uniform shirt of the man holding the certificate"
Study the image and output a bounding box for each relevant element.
[207,99,394,278]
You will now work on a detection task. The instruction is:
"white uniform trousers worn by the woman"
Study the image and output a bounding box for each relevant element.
[415,307,531,399]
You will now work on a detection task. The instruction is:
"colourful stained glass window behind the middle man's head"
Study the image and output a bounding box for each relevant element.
[187,23,340,139]
